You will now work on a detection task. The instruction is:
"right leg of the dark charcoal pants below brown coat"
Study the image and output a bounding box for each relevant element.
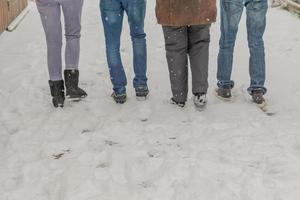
[187,24,210,94]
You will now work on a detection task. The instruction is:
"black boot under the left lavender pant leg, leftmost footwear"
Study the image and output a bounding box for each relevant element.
[49,80,65,108]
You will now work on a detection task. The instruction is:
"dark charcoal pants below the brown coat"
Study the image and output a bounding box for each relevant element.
[163,25,210,102]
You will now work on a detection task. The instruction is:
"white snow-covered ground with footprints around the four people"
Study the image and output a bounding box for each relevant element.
[0,0,300,200]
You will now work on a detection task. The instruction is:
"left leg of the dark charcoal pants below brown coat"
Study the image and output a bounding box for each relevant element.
[163,26,188,102]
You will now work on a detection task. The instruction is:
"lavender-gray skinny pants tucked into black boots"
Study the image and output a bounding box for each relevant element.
[36,0,83,81]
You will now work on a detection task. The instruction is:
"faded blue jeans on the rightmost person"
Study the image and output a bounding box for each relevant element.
[217,0,268,94]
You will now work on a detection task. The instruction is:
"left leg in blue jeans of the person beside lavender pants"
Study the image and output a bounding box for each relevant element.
[100,0,127,94]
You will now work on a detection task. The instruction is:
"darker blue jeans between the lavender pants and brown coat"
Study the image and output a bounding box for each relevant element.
[100,0,147,94]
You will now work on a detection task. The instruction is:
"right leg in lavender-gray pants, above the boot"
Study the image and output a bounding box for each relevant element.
[59,0,83,69]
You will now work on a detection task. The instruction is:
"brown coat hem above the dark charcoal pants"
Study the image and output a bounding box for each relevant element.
[156,0,217,26]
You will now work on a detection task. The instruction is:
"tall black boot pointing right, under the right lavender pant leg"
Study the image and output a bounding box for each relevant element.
[64,69,87,100]
